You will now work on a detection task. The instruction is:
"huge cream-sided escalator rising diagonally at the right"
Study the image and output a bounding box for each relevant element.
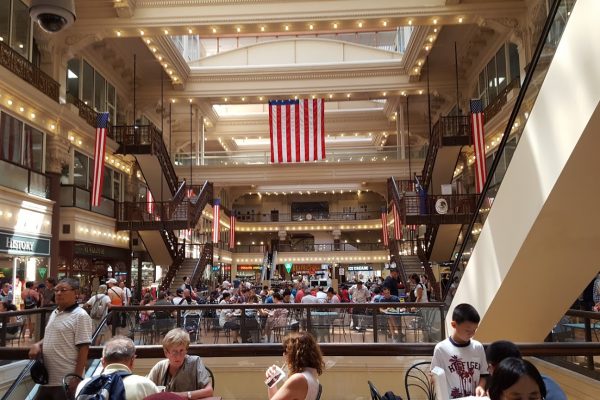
[446,0,600,342]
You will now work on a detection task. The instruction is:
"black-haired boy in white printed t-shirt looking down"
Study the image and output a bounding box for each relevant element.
[431,303,488,399]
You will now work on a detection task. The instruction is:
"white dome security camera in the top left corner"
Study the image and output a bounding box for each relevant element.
[29,0,75,33]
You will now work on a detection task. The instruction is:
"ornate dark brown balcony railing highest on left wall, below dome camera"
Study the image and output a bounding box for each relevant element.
[0,41,60,103]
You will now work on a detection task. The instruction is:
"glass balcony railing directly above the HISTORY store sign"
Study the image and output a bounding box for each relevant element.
[0,158,50,199]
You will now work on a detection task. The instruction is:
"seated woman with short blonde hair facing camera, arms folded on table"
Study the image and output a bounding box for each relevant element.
[148,328,213,399]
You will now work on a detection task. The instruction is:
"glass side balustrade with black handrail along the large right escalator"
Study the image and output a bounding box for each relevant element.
[443,0,575,300]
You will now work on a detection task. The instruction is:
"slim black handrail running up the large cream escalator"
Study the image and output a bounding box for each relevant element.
[442,0,565,301]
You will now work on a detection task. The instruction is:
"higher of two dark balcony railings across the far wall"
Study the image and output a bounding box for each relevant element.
[236,211,381,222]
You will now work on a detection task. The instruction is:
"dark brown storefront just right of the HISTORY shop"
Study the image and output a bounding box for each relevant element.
[58,242,131,293]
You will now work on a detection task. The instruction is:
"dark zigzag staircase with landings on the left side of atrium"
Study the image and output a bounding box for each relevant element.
[112,124,213,288]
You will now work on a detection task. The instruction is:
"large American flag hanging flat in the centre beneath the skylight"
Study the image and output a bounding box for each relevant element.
[269,99,325,164]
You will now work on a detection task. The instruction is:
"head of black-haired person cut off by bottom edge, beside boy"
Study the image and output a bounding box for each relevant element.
[488,357,546,400]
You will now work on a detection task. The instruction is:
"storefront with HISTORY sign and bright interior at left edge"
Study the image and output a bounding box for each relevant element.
[0,231,50,306]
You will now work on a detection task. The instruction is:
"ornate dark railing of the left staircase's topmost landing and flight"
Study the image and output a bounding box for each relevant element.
[112,124,179,194]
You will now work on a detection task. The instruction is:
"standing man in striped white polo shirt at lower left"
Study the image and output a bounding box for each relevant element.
[29,278,92,400]
